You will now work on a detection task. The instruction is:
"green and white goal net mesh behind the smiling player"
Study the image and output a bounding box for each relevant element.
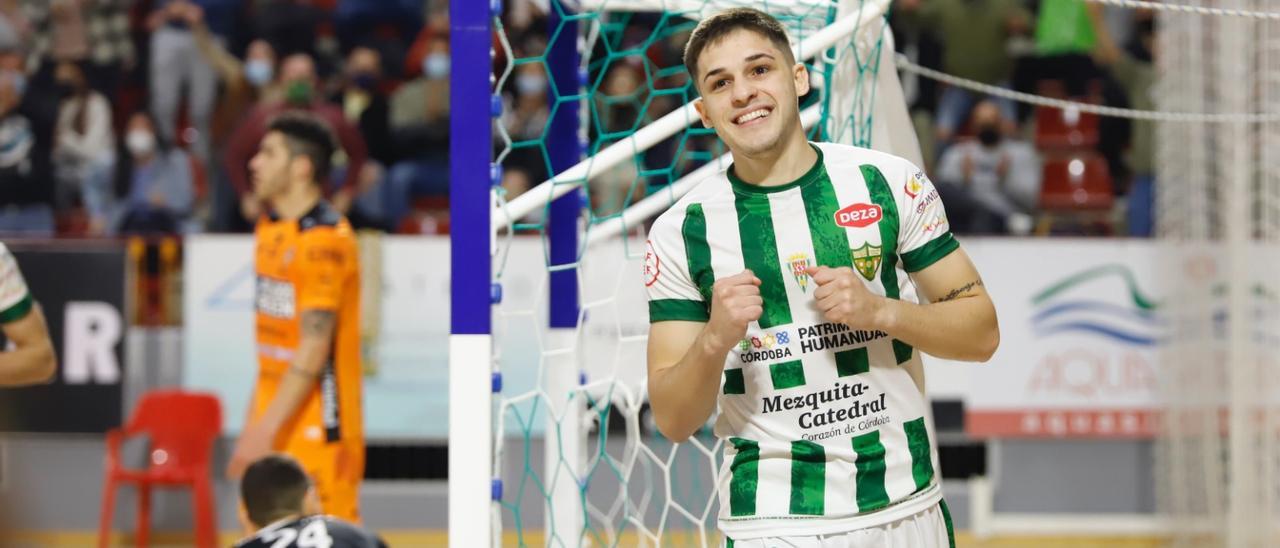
[489,0,896,547]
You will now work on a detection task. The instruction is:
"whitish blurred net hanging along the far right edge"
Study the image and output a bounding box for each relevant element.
[1153,0,1280,547]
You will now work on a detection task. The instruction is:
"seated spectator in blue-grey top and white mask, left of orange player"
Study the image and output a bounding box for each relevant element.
[84,111,196,234]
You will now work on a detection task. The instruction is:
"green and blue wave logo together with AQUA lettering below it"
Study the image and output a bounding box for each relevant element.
[1028,264,1166,398]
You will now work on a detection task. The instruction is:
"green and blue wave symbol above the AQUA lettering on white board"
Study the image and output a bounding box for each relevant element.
[1032,265,1165,346]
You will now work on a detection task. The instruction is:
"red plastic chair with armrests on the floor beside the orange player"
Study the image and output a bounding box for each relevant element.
[97,391,223,548]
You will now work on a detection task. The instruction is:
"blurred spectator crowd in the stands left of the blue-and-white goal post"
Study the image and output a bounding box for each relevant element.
[0,0,449,237]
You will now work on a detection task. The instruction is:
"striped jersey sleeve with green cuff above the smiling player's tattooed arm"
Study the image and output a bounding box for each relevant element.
[897,160,960,273]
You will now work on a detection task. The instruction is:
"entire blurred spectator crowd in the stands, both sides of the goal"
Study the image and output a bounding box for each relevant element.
[0,0,1156,237]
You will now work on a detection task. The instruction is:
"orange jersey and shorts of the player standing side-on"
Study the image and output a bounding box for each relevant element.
[251,202,365,519]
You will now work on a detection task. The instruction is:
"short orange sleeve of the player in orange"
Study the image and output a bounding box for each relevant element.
[294,229,357,311]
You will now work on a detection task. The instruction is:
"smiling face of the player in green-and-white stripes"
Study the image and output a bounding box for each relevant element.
[695,28,809,156]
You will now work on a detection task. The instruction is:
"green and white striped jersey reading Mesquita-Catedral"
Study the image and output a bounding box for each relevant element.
[645,143,959,539]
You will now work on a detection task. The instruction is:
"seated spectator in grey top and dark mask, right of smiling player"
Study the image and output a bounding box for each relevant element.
[936,100,1041,234]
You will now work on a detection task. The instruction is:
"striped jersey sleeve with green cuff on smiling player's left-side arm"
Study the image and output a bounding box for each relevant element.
[644,209,710,323]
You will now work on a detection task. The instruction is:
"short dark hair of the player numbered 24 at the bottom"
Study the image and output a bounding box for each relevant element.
[241,453,311,526]
